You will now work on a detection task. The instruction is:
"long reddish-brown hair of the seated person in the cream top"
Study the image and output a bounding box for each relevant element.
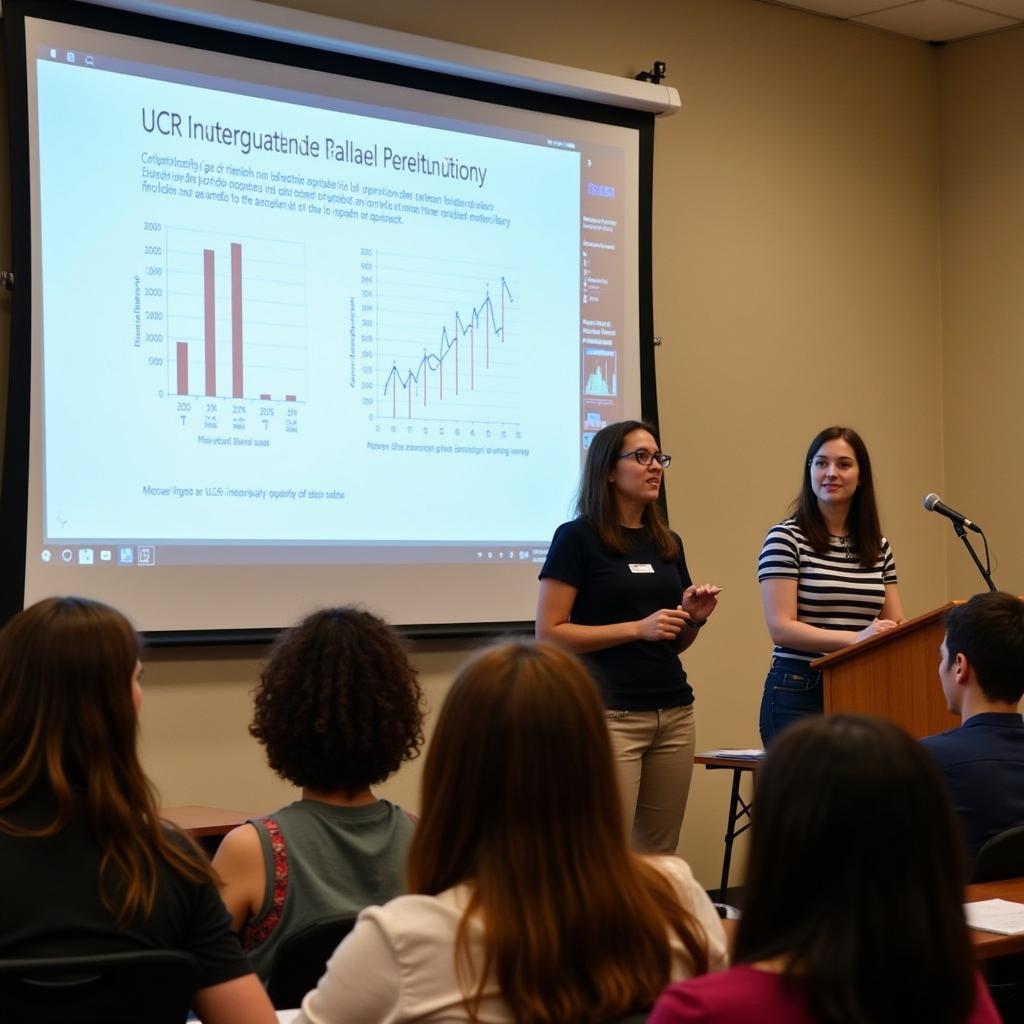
[409,642,708,1024]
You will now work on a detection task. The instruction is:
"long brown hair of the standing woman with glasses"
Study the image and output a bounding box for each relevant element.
[577,420,679,558]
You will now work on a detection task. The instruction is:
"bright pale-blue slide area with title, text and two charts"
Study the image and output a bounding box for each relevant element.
[37,50,585,543]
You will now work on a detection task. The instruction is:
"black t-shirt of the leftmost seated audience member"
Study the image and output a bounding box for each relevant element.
[0,791,252,987]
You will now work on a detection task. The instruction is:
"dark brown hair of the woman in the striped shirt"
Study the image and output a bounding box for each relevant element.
[793,427,882,568]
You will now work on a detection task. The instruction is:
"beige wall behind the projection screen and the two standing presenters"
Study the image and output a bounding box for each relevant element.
[0,0,974,886]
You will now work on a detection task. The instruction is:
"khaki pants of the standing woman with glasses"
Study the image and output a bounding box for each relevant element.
[604,705,696,854]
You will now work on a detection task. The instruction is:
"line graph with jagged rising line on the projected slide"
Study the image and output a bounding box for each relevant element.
[375,252,522,425]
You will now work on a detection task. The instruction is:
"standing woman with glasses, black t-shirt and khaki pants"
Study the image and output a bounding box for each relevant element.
[537,420,720,853]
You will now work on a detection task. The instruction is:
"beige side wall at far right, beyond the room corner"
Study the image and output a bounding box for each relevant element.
[940,25,1024,597]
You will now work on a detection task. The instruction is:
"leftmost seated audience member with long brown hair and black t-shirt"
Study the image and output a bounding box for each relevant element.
[0,597,275,1024]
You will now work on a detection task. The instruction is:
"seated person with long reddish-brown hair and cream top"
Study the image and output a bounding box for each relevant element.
[298,642,725,1024]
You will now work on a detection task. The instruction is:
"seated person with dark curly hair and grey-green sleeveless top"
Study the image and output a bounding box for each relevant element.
[213,607,423,981]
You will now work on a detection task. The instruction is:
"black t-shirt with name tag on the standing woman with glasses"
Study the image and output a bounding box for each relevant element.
[541,517,693,711]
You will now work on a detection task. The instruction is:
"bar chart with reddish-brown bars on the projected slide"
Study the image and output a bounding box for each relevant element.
[165,226,309,402]
